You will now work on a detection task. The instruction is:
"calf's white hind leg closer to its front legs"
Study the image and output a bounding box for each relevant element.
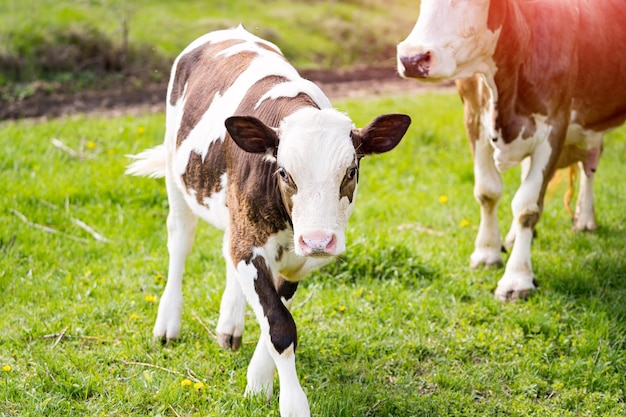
[217,230,246,350]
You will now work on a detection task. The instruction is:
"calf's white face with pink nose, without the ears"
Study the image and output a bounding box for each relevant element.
[277,108,358,256]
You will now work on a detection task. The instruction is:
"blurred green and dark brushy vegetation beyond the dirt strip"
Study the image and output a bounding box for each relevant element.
[0,0,419,100]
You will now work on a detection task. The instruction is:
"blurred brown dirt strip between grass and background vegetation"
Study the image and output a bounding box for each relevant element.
[0,67,453,120]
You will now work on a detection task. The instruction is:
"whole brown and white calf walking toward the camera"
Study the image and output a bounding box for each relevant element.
[128,26,411,417]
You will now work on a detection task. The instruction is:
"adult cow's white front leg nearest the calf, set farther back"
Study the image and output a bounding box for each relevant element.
[470,138,503,268]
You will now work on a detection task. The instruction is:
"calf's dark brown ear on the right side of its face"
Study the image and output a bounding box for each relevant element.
[351,114,411,157]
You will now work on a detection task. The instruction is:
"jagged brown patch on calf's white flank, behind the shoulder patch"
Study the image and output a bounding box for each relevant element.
[182,141,226,205]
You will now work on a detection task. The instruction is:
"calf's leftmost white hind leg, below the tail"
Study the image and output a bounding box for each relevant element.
[153,175,198,340]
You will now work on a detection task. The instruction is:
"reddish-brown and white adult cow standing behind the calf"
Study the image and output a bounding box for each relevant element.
[397,0,626,300]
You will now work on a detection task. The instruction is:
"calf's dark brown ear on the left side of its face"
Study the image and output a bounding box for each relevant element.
[224,116,278,154]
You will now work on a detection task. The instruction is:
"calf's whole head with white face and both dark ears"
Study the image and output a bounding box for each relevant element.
[226,107,411,256]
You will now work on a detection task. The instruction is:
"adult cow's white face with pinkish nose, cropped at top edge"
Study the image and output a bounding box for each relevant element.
[397,0,499,82]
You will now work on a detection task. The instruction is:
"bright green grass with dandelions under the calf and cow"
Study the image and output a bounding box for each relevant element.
[0,94,626,417]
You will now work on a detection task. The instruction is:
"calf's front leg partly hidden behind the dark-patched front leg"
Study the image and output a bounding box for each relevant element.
[246,277,298,399]
